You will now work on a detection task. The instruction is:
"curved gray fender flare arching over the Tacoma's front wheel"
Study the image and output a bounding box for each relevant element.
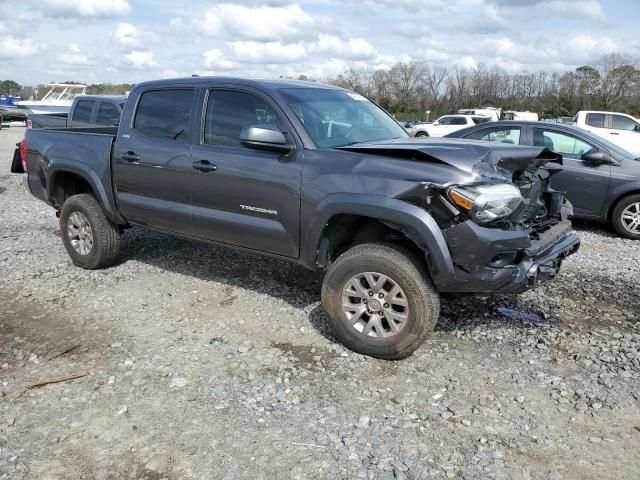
[301,193,454,281]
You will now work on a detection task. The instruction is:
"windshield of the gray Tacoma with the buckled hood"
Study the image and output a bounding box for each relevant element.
[280,88,410,148]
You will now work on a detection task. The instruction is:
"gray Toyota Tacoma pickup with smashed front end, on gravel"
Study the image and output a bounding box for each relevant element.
[12,77,579,359]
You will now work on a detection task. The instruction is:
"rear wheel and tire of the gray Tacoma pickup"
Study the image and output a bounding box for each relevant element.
[60,193,122,270]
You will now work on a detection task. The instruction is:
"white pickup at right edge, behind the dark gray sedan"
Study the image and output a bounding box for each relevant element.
[573,110,640,156]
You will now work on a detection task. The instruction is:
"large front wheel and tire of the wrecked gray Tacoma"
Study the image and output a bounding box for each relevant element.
[322,243,440,360]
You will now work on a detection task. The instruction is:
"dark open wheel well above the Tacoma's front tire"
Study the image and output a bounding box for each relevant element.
[316,214,424,267]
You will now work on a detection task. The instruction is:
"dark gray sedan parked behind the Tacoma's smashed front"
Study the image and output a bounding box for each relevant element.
[449,121,640,240]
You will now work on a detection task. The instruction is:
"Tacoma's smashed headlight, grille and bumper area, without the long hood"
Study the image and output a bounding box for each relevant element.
[425,142,580,293]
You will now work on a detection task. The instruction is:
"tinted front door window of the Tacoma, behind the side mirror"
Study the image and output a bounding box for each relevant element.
[204,90,282,147]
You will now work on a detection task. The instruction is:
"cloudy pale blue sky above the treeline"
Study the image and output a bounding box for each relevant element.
[0,0,640,85]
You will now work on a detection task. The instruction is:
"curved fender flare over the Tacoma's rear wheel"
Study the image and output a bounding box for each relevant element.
[46,159,127,225]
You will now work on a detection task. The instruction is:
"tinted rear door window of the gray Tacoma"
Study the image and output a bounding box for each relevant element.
[133,88,194,143]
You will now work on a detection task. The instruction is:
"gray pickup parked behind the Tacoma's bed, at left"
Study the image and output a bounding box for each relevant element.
[27,95,127,128]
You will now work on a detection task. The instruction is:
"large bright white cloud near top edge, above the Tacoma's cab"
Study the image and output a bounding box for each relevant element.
[194,3,314,42]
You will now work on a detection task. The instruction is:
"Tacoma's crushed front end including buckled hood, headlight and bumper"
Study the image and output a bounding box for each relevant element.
[343,139,580,293]
